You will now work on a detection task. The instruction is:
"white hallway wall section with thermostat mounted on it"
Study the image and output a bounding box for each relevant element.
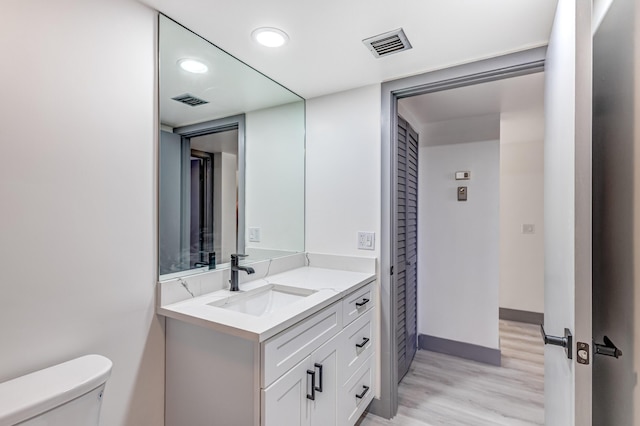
[418,140,500,349]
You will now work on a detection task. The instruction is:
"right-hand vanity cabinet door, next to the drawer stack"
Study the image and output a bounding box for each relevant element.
[307,336,339,426]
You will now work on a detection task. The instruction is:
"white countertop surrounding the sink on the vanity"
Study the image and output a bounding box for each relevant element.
[158,267,375,342]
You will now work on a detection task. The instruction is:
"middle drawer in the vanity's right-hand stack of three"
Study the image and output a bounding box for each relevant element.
[340,309,375,384]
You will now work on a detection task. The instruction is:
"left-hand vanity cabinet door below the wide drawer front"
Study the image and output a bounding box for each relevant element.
[262,356,318,426]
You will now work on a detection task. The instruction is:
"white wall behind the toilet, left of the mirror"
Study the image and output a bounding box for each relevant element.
[0,0,164,426]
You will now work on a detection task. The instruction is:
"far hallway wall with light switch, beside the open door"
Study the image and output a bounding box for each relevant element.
[500,108,544,313]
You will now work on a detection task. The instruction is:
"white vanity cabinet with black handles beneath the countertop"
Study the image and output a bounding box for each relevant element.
[165,282,375,426]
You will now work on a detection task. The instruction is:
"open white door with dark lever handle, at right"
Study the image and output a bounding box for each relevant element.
[544,0,592,426]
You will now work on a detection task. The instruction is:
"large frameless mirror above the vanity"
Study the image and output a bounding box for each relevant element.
[158,15,305,280]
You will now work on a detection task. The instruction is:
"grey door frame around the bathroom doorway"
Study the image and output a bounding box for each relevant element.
[369,46,546,419]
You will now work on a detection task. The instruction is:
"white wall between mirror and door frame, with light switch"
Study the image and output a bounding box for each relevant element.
[305,84,381,257]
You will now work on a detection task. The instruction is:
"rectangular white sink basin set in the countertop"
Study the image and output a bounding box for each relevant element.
[208,284,316,317]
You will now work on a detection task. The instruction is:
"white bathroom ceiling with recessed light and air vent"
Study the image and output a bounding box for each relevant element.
[140,0,557,98]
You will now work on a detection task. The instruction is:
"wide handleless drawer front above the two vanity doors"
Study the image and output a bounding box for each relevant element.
[261,302,342,389]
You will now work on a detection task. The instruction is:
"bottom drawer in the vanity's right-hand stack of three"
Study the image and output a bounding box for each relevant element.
[338,356,375,425]
